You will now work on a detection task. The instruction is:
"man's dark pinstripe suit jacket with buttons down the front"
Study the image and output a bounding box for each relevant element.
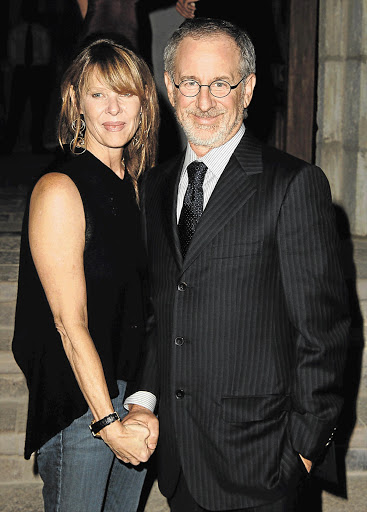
[140,134,348,510]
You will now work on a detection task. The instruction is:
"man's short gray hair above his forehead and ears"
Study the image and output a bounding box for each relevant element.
[163,18,256,79]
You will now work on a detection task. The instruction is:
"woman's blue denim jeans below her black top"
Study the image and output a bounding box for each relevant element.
[37,381,146,512]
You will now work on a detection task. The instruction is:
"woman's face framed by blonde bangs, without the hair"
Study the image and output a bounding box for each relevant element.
[80,71,141,153]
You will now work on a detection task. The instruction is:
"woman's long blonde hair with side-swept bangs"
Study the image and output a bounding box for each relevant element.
[58,39,159,197]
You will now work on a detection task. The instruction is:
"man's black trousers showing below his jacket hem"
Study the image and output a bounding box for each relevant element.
[168,471,300,512]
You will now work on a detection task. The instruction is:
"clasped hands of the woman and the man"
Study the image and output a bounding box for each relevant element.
[100,404,159,466]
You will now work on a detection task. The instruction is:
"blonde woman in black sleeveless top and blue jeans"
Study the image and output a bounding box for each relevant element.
[13,39,158,512]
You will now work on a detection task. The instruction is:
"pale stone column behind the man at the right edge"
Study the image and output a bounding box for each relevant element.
[316,0,367,236]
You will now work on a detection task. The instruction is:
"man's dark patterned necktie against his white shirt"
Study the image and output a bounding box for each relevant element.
[178,160,208,257]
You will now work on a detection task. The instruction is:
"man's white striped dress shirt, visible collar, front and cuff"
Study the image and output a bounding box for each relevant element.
[124,124,245,412]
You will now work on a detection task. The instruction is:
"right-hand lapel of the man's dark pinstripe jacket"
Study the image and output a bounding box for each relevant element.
[182,134,262,270]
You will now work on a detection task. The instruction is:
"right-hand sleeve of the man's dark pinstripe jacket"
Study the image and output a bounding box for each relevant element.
[277,166,349,461]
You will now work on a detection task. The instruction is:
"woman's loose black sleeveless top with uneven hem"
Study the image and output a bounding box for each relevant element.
[13,151,146,459]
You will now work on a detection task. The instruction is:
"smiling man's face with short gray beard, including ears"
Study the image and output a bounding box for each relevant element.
[165,35,255,156]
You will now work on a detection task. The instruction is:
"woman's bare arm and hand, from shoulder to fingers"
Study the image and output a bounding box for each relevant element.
[29,173,150,464]
